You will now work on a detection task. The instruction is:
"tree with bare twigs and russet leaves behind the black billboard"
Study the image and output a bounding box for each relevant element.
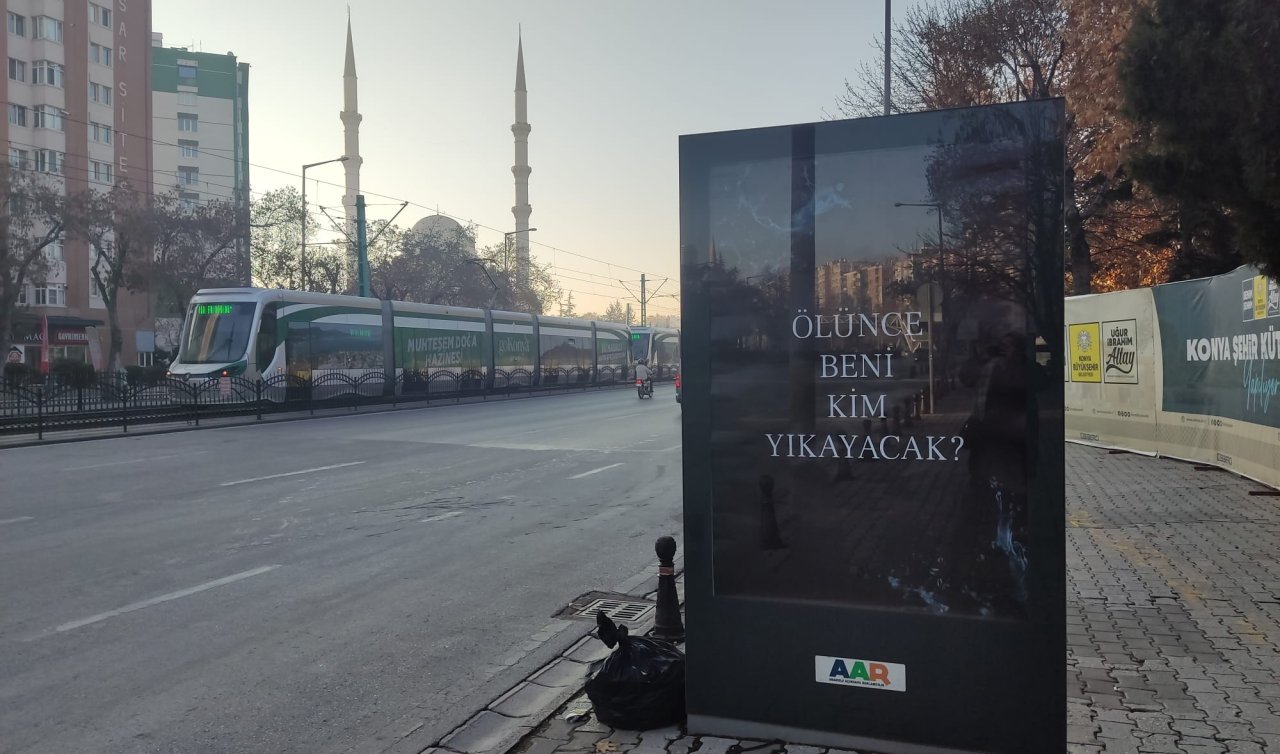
[837,0,1153,293]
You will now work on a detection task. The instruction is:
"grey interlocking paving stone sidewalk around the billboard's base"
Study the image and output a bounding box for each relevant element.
[481,445,1280,754]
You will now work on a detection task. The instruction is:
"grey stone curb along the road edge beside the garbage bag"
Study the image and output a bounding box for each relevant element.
[415,556,684,754]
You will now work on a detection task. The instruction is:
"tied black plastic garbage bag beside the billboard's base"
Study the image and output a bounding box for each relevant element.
[586,612,685,731]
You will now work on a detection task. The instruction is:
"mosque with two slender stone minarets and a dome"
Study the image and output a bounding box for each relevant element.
[338,15,534,283]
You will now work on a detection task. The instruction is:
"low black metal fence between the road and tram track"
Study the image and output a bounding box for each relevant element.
[0,366,675,439]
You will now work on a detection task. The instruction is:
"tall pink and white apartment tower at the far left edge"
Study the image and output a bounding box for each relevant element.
[0,0,155,369]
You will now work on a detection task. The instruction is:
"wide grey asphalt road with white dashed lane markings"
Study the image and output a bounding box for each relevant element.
[0,384,681,754]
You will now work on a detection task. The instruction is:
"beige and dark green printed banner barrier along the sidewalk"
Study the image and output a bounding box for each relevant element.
[1065,268,1280,485]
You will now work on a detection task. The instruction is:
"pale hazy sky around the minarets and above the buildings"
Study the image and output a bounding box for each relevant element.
[152,0,915,315]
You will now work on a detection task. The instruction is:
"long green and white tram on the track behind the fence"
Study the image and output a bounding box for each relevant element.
[169,288,680,393]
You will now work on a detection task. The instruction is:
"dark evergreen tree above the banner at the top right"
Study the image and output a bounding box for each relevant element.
[1120,0,1280,279]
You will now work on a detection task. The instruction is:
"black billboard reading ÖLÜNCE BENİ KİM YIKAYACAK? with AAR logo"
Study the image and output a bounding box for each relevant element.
[680,100,1066,754]
